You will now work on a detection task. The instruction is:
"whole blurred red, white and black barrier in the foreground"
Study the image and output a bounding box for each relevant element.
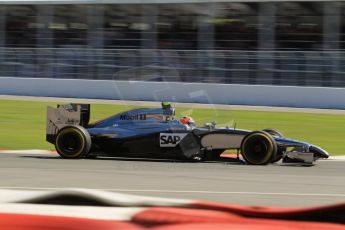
[0,189,345,230]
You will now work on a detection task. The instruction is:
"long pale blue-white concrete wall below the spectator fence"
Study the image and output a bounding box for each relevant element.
[0,77,345,109]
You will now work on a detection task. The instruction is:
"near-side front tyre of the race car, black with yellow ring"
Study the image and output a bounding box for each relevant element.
[241,131,277,165]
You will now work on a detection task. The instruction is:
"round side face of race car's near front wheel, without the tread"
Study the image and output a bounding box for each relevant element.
[243,134,273,164]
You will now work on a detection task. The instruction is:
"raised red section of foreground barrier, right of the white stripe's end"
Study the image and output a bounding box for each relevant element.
[132,207,345,230]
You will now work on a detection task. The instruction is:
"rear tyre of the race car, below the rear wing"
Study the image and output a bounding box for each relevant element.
[55,126,91,159]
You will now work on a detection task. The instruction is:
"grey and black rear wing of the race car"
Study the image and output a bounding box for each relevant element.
[46,103,90,144]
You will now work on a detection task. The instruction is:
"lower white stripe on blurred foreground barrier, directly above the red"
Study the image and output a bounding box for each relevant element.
[0,203,145,221]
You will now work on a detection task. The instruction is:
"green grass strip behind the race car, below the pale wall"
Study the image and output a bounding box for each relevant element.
[0,100,345,155]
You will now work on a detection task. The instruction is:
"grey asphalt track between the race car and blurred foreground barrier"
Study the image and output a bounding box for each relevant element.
[0,153,345,207]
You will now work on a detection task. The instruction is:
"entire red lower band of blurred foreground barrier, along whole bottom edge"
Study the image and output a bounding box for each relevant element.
[0,208,345,230]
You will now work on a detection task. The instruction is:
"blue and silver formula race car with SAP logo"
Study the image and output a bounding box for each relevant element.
[46,103,329,165]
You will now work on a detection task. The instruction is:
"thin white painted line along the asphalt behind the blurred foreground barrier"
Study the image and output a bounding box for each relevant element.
[0,187,345,197]
